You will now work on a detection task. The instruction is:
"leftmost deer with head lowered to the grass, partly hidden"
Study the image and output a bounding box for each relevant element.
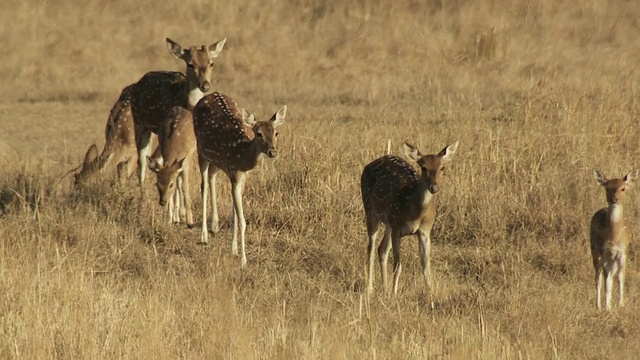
[75,85,160,186]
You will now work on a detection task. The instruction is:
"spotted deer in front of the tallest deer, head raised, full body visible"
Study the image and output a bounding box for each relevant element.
[193,92,287,266]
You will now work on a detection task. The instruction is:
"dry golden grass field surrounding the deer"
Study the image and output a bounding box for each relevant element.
[0,0,640,359]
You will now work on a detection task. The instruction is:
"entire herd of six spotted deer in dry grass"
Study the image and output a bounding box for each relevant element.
[75,38,638,310]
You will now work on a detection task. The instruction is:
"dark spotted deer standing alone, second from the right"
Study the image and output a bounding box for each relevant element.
[361,141,458,295]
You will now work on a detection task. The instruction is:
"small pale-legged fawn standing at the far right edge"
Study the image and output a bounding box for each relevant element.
[590,170,638,310]
